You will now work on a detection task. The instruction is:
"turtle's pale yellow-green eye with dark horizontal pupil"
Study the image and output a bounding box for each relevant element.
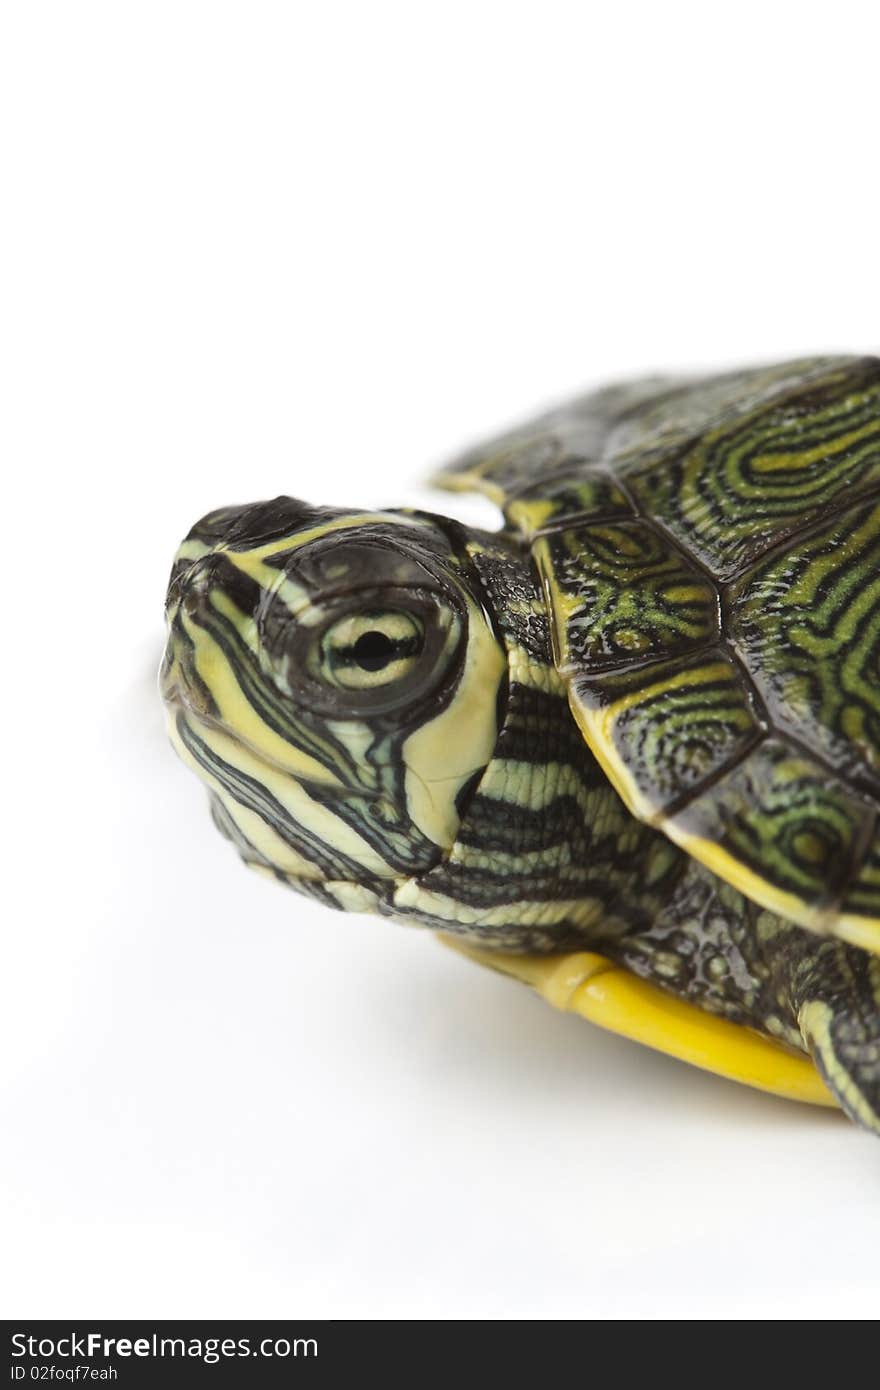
[314,610,425,691]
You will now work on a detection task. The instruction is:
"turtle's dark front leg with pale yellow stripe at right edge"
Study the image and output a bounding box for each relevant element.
[790,941,880,1134]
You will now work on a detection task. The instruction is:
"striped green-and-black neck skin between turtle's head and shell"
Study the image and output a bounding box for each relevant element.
[378,534,688,952]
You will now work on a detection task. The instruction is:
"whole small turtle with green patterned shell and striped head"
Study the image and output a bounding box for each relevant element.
[161,356,880,1133]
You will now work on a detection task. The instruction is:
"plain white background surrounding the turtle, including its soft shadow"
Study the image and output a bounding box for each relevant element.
[0,0,880,1318]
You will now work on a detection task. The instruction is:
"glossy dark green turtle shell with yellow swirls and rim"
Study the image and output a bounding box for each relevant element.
[435,357,880,951]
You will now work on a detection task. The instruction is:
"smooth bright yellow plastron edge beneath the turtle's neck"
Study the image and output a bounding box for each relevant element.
[441,935,837,1106]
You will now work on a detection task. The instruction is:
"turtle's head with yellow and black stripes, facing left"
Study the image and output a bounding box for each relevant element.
[161,498,507,910]
